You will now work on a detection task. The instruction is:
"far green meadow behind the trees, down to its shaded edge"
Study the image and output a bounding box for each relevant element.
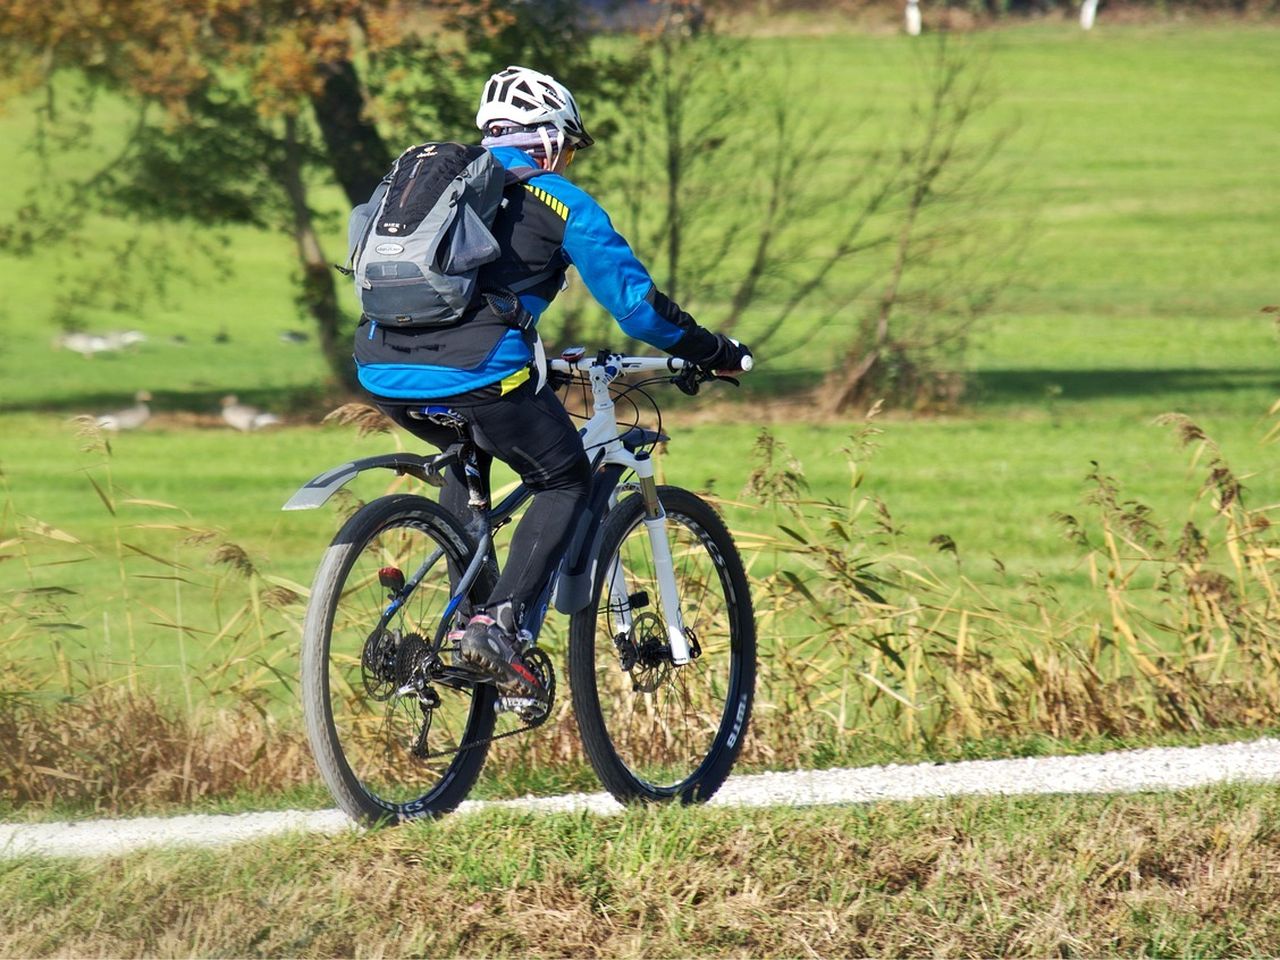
[0,23,1280,412]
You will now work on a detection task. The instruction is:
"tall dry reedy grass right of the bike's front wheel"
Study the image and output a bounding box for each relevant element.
[739,404,1280,762]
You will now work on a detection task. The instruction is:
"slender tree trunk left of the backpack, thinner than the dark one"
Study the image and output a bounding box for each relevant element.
[280,116,358,390]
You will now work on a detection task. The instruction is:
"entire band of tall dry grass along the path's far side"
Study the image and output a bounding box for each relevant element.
[0,404,1280,812]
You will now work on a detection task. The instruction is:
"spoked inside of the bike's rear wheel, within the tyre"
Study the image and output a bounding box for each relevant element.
[328,518,481,814]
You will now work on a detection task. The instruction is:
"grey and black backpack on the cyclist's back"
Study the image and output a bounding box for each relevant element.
[347,143,543,329]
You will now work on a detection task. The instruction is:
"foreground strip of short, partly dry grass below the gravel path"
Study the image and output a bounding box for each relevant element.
[0,787,1280,956]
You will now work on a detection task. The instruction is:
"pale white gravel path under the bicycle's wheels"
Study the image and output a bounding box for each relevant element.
[0,740,1280,856]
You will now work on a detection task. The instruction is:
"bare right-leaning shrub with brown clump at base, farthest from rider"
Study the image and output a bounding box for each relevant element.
[815,37,1027,412]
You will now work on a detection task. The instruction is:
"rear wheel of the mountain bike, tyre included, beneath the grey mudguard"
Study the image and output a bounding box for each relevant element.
[302,495,494,824]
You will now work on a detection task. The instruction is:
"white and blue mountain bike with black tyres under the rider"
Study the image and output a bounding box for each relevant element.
[284,348,755,824]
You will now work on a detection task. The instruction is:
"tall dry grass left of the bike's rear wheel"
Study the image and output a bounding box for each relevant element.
[0,419,312,812]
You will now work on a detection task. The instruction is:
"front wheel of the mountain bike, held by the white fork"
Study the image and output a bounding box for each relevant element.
[568,486,755,803]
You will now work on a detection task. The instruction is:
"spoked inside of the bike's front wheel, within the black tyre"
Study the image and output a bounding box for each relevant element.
[595,511,740,795]
